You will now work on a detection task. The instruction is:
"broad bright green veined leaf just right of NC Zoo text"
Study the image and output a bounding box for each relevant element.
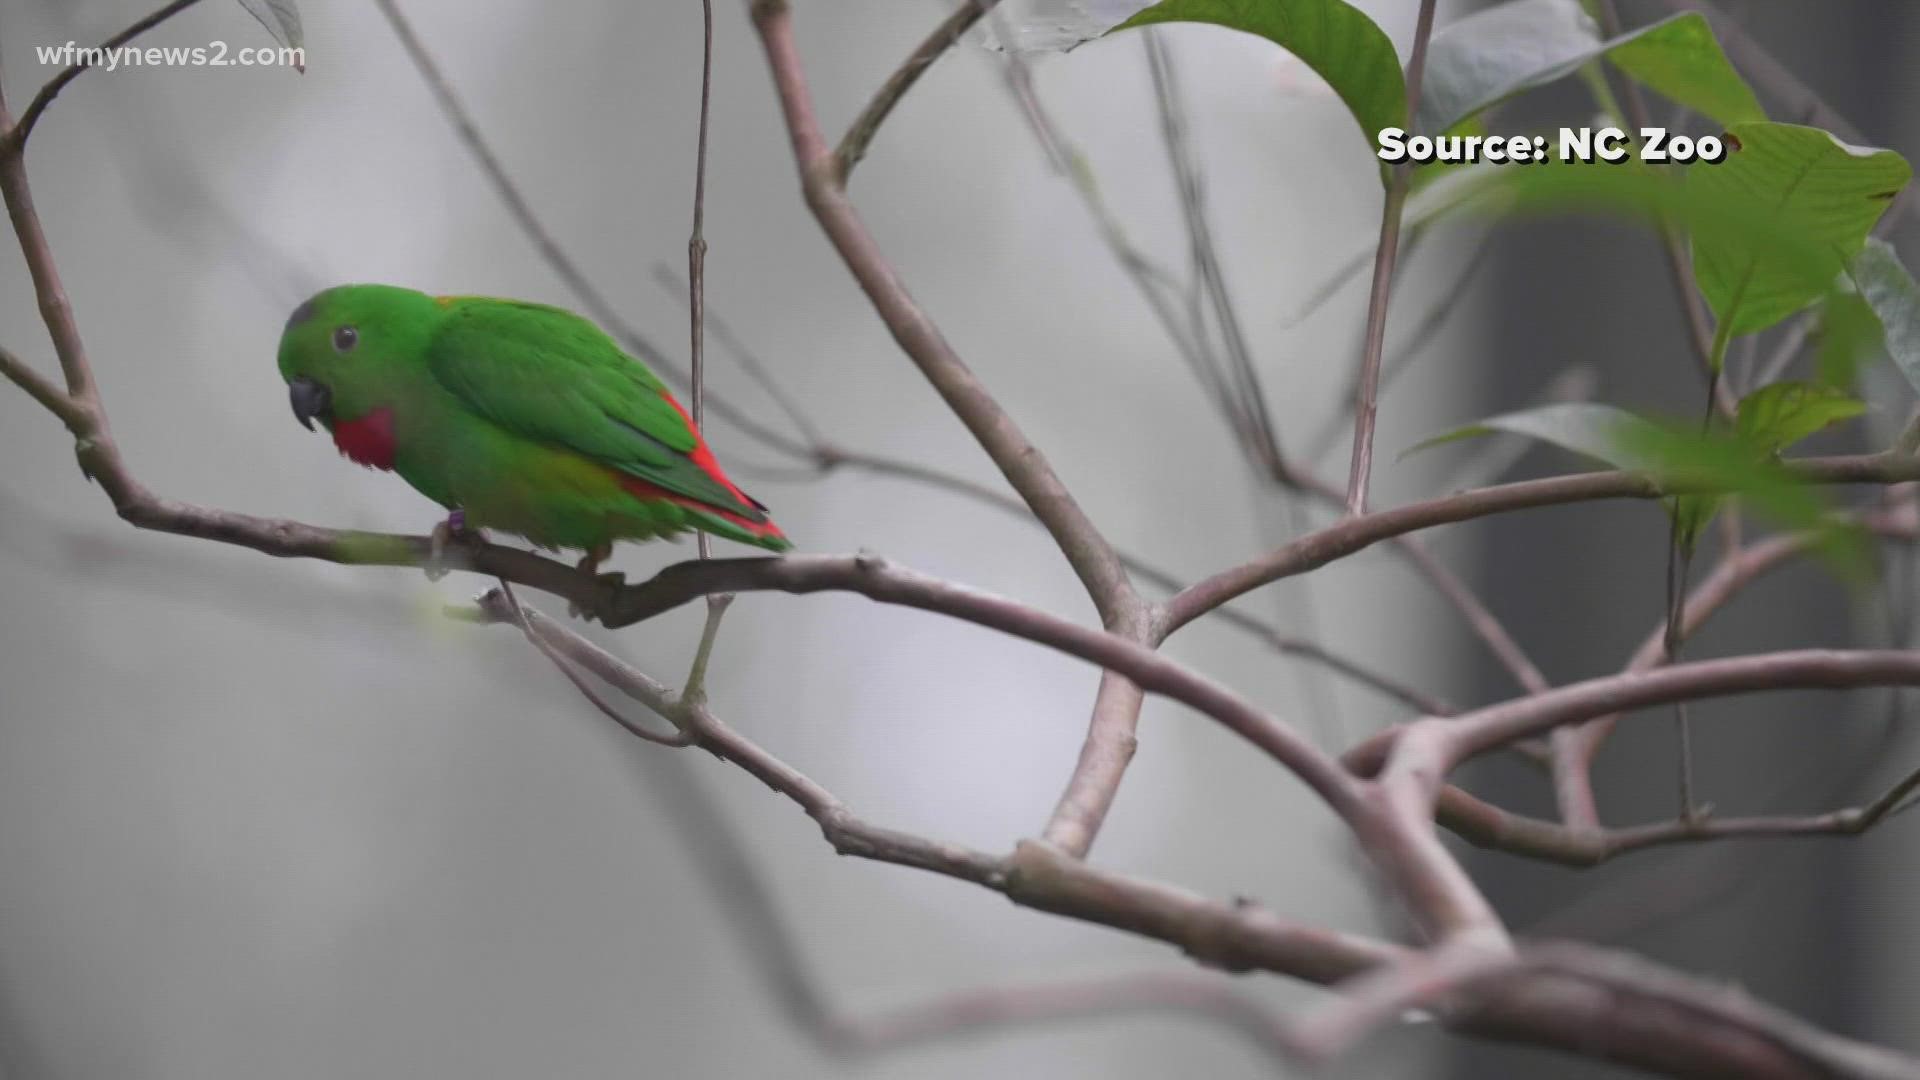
[1686,123,1912,338]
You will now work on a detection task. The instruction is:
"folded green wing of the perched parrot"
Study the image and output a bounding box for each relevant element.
[426,296,766,523]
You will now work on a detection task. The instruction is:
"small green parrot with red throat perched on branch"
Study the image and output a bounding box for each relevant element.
[280,284,791,573]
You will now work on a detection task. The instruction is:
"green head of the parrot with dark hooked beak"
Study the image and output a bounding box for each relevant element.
[280,284,444,430]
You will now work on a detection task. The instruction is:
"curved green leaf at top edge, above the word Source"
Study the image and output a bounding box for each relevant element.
[1114,0,1407,164]
